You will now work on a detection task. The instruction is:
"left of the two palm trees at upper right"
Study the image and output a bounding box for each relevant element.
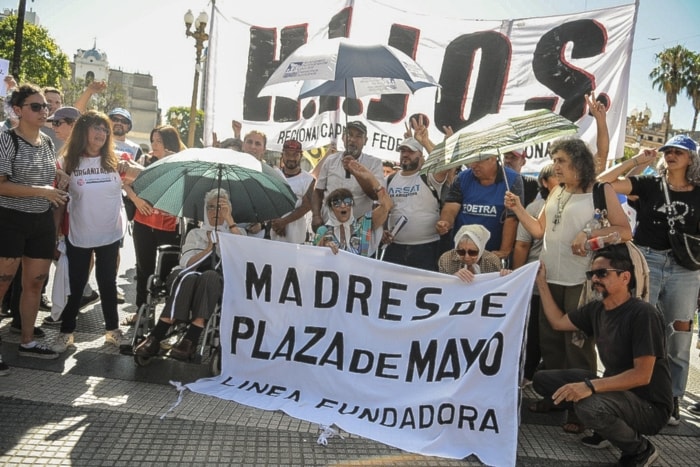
[649,45,691,140]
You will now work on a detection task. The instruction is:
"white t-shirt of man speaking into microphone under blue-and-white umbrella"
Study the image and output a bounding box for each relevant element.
[316,152,386,219]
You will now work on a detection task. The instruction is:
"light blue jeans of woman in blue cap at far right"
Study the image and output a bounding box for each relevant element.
[639,247,700,397]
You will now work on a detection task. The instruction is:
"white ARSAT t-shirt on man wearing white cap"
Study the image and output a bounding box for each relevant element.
[387,172,442,245]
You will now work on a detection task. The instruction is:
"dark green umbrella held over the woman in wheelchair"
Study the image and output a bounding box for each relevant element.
[132,147,296,222]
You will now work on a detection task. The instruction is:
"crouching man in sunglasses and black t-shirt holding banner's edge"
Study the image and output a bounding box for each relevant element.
[532,244,673,465]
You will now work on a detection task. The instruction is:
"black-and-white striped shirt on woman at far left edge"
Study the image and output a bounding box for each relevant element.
[0,131,56,213]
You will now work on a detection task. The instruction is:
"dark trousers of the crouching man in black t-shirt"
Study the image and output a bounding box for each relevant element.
[532,369,671,454]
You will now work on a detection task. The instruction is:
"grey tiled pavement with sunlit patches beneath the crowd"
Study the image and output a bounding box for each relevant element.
[0,238,700,466]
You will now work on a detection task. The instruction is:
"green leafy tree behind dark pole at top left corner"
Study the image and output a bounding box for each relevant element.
[0,16,70,88]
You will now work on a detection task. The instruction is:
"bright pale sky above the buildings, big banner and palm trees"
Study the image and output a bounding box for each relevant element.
[0,0,700,132]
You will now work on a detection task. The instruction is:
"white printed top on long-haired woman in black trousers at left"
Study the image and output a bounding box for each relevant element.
[60,157,127,248]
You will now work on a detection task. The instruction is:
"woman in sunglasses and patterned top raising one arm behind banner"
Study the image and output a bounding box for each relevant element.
[314,161,393,256]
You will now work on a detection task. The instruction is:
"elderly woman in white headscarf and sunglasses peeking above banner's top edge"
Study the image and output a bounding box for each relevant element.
[438,224,501,282]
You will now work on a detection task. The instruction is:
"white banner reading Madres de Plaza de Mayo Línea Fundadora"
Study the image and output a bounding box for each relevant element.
[188,235,537,465]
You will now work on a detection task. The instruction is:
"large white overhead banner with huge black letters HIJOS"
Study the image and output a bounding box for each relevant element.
[205,0,636,169]
